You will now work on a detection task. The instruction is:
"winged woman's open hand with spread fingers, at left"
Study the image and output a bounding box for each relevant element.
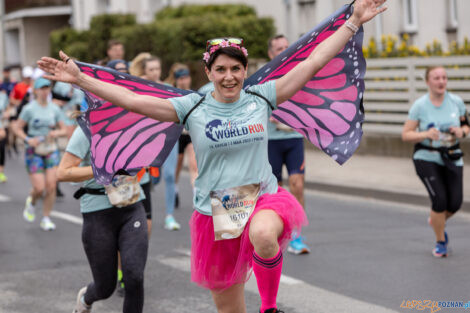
[37,51,80,84]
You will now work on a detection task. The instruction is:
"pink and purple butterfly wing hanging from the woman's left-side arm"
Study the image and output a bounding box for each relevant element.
[76,62,193,185]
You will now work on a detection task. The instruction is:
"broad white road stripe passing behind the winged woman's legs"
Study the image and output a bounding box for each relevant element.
[156,249,398,313]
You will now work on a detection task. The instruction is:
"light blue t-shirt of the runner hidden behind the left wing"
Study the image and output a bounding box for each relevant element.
[65,127,145,213]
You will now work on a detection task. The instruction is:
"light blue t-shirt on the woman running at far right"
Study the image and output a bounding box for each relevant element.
[408,92,465,166]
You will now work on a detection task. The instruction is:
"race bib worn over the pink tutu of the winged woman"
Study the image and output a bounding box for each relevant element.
[210,184,260,240]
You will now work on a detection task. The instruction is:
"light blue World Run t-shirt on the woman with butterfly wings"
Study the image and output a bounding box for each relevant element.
[170,81,277,215]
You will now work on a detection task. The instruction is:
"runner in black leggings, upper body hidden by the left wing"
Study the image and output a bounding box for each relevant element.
[57,127,148,313]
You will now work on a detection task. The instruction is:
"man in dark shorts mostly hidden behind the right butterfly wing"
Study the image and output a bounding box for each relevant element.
[268,35,310,254]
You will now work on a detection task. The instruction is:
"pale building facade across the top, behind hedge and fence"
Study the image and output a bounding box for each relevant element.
[0,0,470,72]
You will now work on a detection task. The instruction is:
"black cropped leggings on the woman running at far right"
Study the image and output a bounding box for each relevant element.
[414,160,463,213]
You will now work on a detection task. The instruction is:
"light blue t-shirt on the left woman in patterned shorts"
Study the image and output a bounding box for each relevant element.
[19,100,64,137]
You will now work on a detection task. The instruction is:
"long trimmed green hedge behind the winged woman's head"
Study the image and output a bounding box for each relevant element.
[50,5,275,71]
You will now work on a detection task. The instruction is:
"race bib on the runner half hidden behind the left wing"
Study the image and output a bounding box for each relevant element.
[104,175,140,208]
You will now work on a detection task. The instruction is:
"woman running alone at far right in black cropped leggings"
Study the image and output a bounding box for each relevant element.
[402,66,470,258]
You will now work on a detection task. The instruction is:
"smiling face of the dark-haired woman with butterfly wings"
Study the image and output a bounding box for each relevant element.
[206,54,246,103]
